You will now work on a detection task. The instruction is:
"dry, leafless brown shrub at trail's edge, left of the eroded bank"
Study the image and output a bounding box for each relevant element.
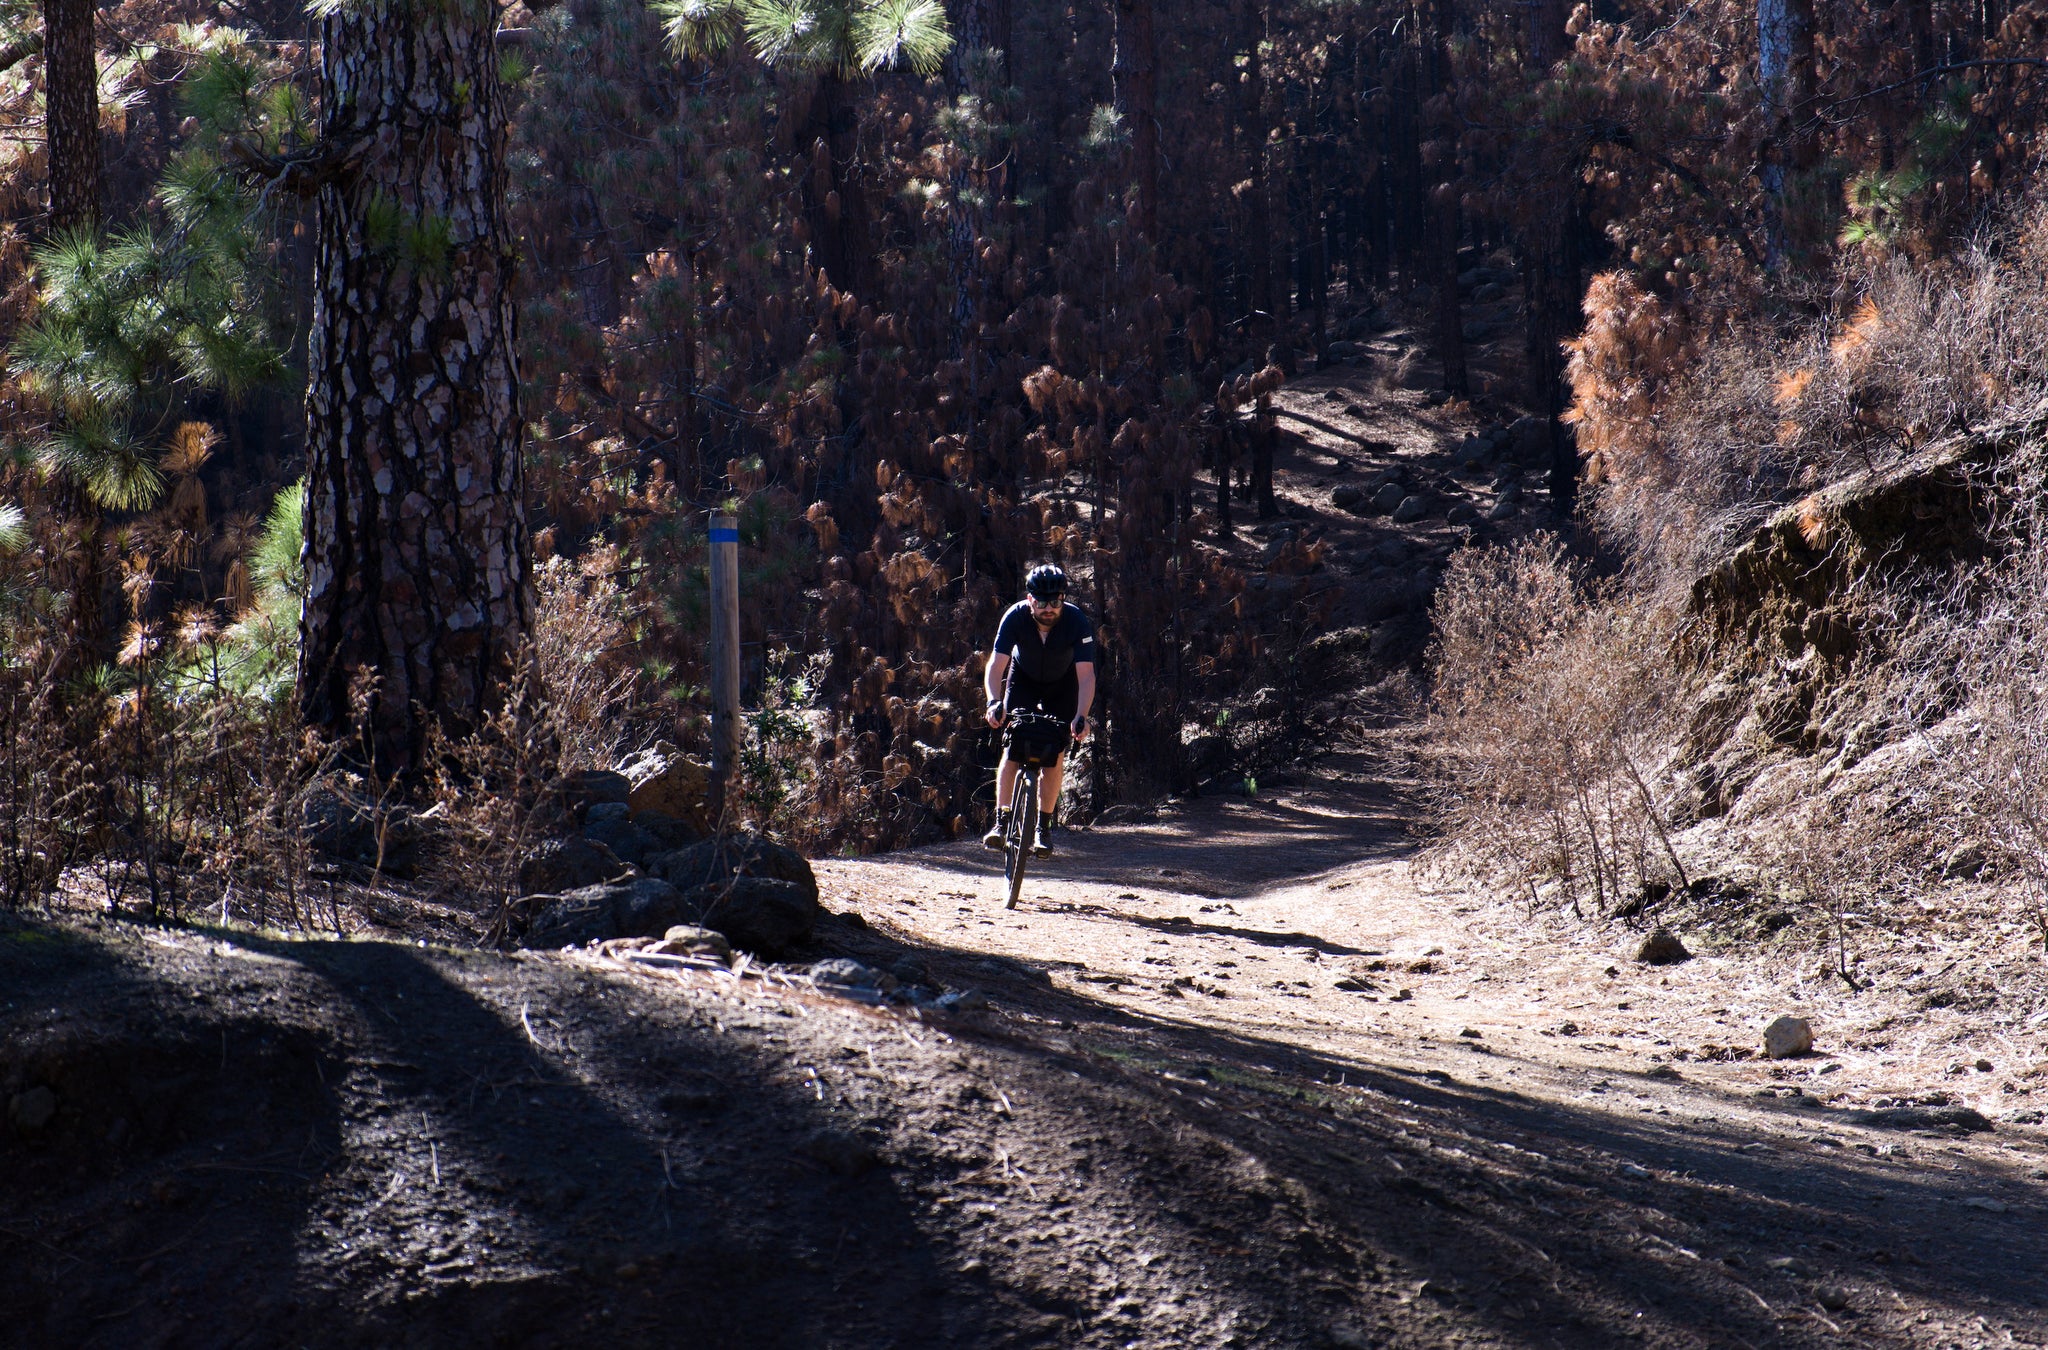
[1430,539,1688,916]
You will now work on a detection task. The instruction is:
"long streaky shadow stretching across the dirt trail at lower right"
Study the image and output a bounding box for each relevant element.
[819,913,2048,1348]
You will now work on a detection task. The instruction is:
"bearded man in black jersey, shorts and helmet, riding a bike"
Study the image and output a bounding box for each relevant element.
[981,563,1096,854]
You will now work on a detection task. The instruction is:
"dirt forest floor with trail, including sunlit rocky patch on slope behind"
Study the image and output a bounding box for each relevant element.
[0,346,2048,1350]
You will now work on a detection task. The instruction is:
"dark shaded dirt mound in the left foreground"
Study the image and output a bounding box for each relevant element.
[0,924,1001,1348]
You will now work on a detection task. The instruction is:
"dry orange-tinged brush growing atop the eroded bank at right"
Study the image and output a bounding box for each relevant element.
[1567,205,2048,586]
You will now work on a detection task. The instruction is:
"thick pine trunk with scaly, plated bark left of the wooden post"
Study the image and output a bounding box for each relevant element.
[299,0,532,772]
